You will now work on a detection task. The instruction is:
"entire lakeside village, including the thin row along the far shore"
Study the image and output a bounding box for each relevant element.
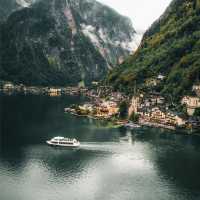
[0,79,200,133]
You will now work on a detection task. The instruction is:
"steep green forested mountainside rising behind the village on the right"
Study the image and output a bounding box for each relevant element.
[107,0,200,99]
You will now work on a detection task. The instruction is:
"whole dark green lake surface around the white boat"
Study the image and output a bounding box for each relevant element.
[0,96,200,200]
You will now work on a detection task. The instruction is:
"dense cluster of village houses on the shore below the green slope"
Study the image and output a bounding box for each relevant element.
[65,79,200,133]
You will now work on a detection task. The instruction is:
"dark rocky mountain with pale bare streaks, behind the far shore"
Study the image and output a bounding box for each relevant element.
[0,0,137,85]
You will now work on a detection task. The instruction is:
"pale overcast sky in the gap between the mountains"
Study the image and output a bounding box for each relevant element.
[98,0,172,32]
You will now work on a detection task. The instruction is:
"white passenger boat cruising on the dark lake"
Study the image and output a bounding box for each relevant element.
[47,137,80,148]
